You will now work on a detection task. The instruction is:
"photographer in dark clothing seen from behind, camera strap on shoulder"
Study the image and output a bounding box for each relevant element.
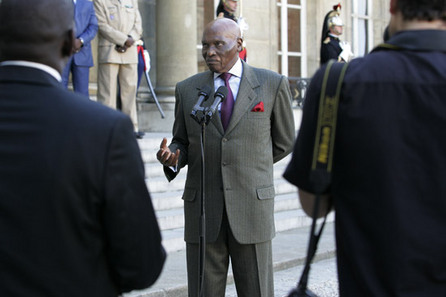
[284,0,446,297]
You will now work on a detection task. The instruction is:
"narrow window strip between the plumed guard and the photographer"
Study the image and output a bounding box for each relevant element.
[352,0,373,57]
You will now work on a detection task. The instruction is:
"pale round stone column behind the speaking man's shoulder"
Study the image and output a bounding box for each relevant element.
[156,0,197,96]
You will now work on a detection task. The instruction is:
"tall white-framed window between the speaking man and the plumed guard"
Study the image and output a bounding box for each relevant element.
[277,0,307,77]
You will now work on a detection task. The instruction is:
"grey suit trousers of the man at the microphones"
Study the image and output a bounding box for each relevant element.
[186,212,274,297]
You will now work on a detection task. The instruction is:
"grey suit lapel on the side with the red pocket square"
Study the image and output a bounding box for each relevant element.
[225,61,260,133]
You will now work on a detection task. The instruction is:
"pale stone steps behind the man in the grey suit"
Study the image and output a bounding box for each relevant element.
[138,133,322,252]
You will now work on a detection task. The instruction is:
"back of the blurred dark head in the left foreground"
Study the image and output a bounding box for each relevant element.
[0,0,74,70]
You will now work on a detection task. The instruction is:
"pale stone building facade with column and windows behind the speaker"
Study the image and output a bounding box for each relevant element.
[86,0,390,131]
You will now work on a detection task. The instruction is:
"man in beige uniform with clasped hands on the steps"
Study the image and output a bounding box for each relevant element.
[94,0,144,138]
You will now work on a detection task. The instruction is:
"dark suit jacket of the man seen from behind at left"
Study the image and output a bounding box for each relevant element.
[0,66,165,297]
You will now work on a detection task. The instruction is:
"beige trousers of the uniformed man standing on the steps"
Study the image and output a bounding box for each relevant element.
[98,63,138,131]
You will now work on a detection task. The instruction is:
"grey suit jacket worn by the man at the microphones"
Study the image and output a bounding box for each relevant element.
[165,62,295,244]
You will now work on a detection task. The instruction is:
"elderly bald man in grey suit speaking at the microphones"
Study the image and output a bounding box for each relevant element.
[157,19,295,297]
